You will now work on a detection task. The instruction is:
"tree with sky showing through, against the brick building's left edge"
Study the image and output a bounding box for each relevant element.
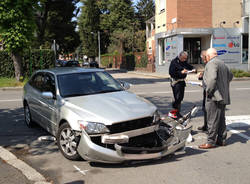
[135,0,155,30]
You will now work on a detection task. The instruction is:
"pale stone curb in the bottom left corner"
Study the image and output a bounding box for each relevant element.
[0,146,51,184]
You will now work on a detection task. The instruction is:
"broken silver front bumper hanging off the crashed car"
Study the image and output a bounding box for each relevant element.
[78,125,192,163]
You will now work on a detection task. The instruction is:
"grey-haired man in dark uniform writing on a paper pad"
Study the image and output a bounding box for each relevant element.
[169,51,195,118]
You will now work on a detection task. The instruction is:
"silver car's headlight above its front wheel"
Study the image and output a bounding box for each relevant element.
[78,120,109,134]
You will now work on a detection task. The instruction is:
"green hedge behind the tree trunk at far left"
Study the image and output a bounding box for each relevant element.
[0,49,55,77]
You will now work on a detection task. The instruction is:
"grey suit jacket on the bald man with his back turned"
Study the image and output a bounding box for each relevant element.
[203,57,233,105]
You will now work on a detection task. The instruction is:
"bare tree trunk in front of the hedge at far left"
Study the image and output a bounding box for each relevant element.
[11,52,23,81]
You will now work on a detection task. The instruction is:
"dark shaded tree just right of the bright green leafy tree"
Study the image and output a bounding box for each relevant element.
[36,0,80,53]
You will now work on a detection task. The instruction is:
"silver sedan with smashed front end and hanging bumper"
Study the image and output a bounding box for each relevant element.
[23,68,191,163]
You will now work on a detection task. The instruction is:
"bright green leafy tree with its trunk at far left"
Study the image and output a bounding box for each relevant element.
[0,0,37,81]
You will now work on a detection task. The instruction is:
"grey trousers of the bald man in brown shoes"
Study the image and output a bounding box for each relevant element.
[205,98,227,145]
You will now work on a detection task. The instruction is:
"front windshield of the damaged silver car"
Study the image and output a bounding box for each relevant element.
[57,71,124,97]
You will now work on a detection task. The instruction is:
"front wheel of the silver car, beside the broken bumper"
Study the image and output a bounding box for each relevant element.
[57,123,81,160]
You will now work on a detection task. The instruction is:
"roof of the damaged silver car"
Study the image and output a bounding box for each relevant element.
[36,67,104,75]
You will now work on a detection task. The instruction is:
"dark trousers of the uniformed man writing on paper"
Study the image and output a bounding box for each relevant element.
[172,81,186,112]
